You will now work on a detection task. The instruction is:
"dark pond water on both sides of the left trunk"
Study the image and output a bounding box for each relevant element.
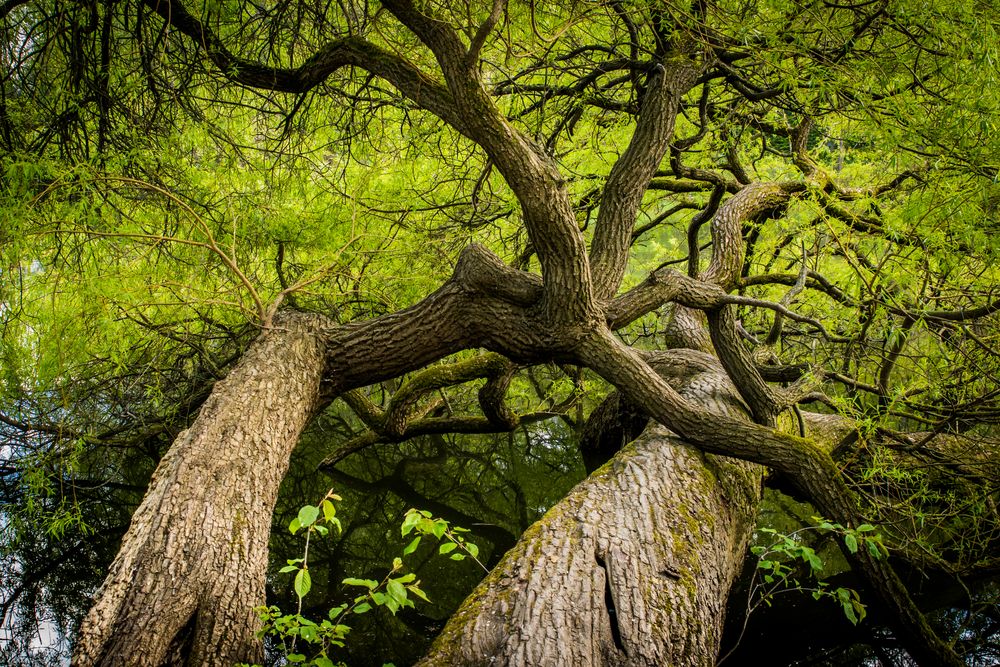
[0,410,584,667]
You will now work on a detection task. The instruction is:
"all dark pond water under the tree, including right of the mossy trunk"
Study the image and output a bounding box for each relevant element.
[0,411,1000,667]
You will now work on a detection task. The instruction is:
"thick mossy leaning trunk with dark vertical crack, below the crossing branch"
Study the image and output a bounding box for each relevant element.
[419,366,763,667]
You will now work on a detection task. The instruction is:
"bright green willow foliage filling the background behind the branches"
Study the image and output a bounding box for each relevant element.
[0,0,1000,664]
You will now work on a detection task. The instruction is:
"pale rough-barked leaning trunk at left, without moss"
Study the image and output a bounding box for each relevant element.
[73,314,324,667]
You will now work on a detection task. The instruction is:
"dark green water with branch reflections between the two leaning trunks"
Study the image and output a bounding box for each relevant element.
[269,416,584,667]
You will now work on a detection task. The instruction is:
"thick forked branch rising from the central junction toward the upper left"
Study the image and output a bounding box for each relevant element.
[145,0,592,321]
